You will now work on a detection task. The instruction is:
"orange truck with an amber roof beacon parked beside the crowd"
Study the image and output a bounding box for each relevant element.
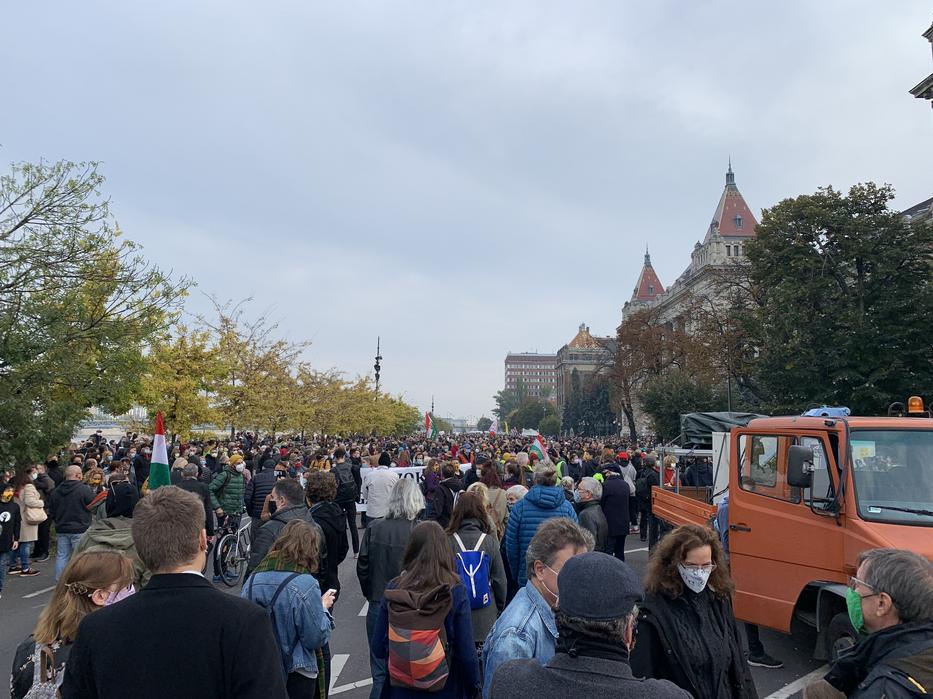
[652,397,933,660]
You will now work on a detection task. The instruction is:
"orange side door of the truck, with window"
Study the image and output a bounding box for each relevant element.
[729,432,843,632]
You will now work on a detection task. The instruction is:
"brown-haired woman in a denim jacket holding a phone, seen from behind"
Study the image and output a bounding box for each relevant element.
[241,520,334,699]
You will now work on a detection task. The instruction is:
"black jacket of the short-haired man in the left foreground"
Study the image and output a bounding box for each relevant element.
[61,573,287,699]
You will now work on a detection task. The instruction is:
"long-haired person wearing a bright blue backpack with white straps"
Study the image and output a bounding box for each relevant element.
[447,494,506,650]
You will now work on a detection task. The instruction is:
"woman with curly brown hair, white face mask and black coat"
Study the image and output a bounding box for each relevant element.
[631,524,758,699]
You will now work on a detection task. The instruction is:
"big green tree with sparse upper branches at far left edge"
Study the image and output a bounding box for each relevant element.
[0,162,190,464]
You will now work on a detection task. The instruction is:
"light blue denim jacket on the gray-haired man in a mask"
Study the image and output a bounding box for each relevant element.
[483,582,557,699]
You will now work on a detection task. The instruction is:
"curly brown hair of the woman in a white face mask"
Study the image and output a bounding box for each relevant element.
[645,524,735,599]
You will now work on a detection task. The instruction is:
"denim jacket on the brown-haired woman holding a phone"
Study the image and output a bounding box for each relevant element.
[240,570,333,675]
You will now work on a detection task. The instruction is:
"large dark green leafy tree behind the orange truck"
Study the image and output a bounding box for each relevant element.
[747,183,933,414]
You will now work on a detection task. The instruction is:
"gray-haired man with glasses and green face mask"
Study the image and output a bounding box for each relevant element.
[804,549,933,699]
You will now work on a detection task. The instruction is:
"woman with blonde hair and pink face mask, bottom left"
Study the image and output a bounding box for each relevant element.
[10,551,135,699]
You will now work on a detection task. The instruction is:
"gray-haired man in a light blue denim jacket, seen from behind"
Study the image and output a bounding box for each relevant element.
[483,517,593,699]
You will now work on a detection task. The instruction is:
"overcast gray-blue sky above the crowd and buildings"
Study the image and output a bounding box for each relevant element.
[0,0,933,417]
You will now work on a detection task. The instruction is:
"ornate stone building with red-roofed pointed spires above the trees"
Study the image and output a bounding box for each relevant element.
[622,163,758,325]
